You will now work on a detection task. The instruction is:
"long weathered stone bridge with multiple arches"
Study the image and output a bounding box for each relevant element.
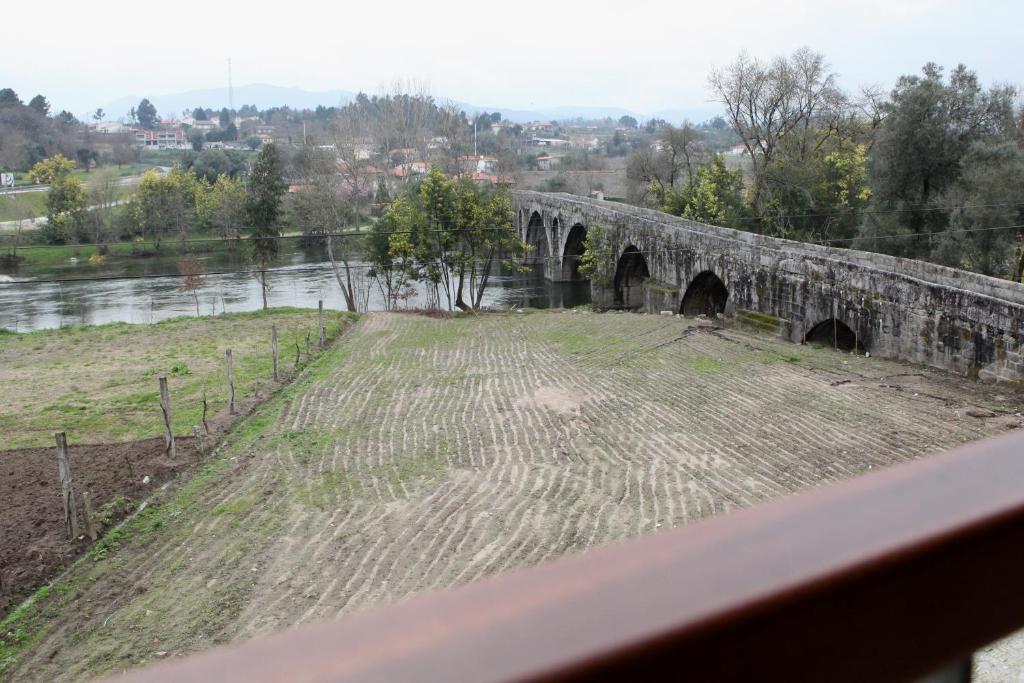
[512,190,1024,381]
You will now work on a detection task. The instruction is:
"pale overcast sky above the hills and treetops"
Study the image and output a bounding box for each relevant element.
[0,0,1024,113]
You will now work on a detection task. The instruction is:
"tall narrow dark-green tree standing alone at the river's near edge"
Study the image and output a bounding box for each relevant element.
[247,143,287,308]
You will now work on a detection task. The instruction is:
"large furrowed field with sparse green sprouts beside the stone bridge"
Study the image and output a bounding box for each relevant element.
[5,312,1022,680]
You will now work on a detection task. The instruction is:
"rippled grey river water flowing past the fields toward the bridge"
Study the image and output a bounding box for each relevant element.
[0,250,590,332]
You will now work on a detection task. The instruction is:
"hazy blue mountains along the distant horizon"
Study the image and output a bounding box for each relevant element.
[96,83,721,124]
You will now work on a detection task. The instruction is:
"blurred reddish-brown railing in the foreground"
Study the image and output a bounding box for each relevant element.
[116,433,1024,683]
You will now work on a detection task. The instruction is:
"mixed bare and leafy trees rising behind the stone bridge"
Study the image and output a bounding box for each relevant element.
[628,48,1024,280]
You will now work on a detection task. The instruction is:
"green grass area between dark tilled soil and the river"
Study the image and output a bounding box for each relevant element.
[0,308,349,450]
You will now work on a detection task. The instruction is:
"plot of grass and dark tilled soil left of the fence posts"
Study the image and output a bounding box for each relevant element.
[0,309,352,626]
